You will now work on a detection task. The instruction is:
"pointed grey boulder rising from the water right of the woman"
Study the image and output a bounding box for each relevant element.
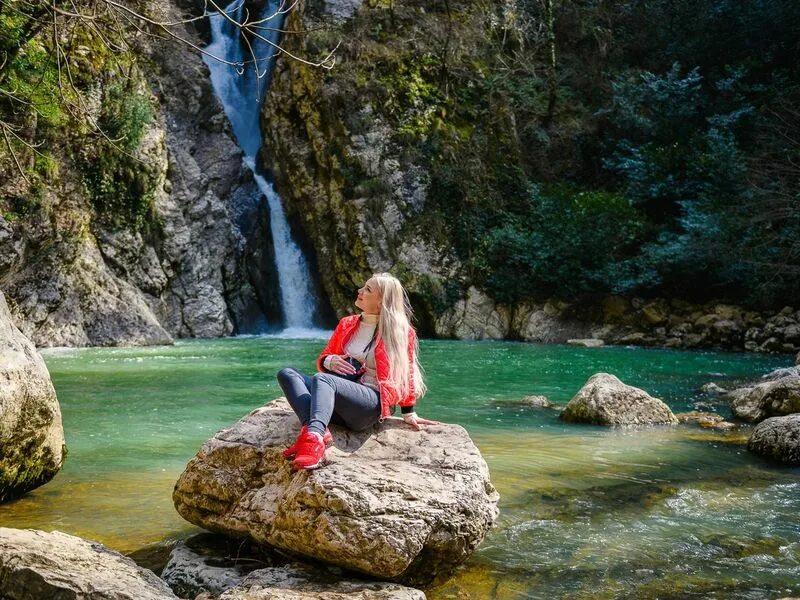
[561,373,678,425]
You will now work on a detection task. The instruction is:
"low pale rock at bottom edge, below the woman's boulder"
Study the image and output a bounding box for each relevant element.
[211,565,425,600]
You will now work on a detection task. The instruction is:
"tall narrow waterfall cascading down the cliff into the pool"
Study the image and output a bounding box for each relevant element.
[203,0,319,336]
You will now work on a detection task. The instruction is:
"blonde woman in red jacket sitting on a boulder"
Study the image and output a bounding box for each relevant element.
[278,273,438,470]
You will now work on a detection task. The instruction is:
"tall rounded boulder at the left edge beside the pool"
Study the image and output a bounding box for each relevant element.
[0,293,66,502]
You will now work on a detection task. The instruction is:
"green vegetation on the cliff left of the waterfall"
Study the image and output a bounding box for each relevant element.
[0,0,157,228]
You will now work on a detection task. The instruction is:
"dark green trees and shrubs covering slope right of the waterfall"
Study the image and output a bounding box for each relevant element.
[298,0,800,307]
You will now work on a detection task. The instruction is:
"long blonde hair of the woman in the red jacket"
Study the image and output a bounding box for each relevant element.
[372,273,427,398]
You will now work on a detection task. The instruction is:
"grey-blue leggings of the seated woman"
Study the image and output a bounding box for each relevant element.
[278,367,381,435]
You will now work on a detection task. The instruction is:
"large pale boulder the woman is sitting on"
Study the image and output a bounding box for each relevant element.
[173,399,499,584]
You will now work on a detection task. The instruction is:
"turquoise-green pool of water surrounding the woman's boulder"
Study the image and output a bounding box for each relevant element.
[0,338,800,599]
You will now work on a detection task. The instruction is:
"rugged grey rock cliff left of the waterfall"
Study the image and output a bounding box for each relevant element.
[0,3,278,346]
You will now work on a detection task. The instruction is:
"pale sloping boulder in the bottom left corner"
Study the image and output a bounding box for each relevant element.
[0,527,177,600]
